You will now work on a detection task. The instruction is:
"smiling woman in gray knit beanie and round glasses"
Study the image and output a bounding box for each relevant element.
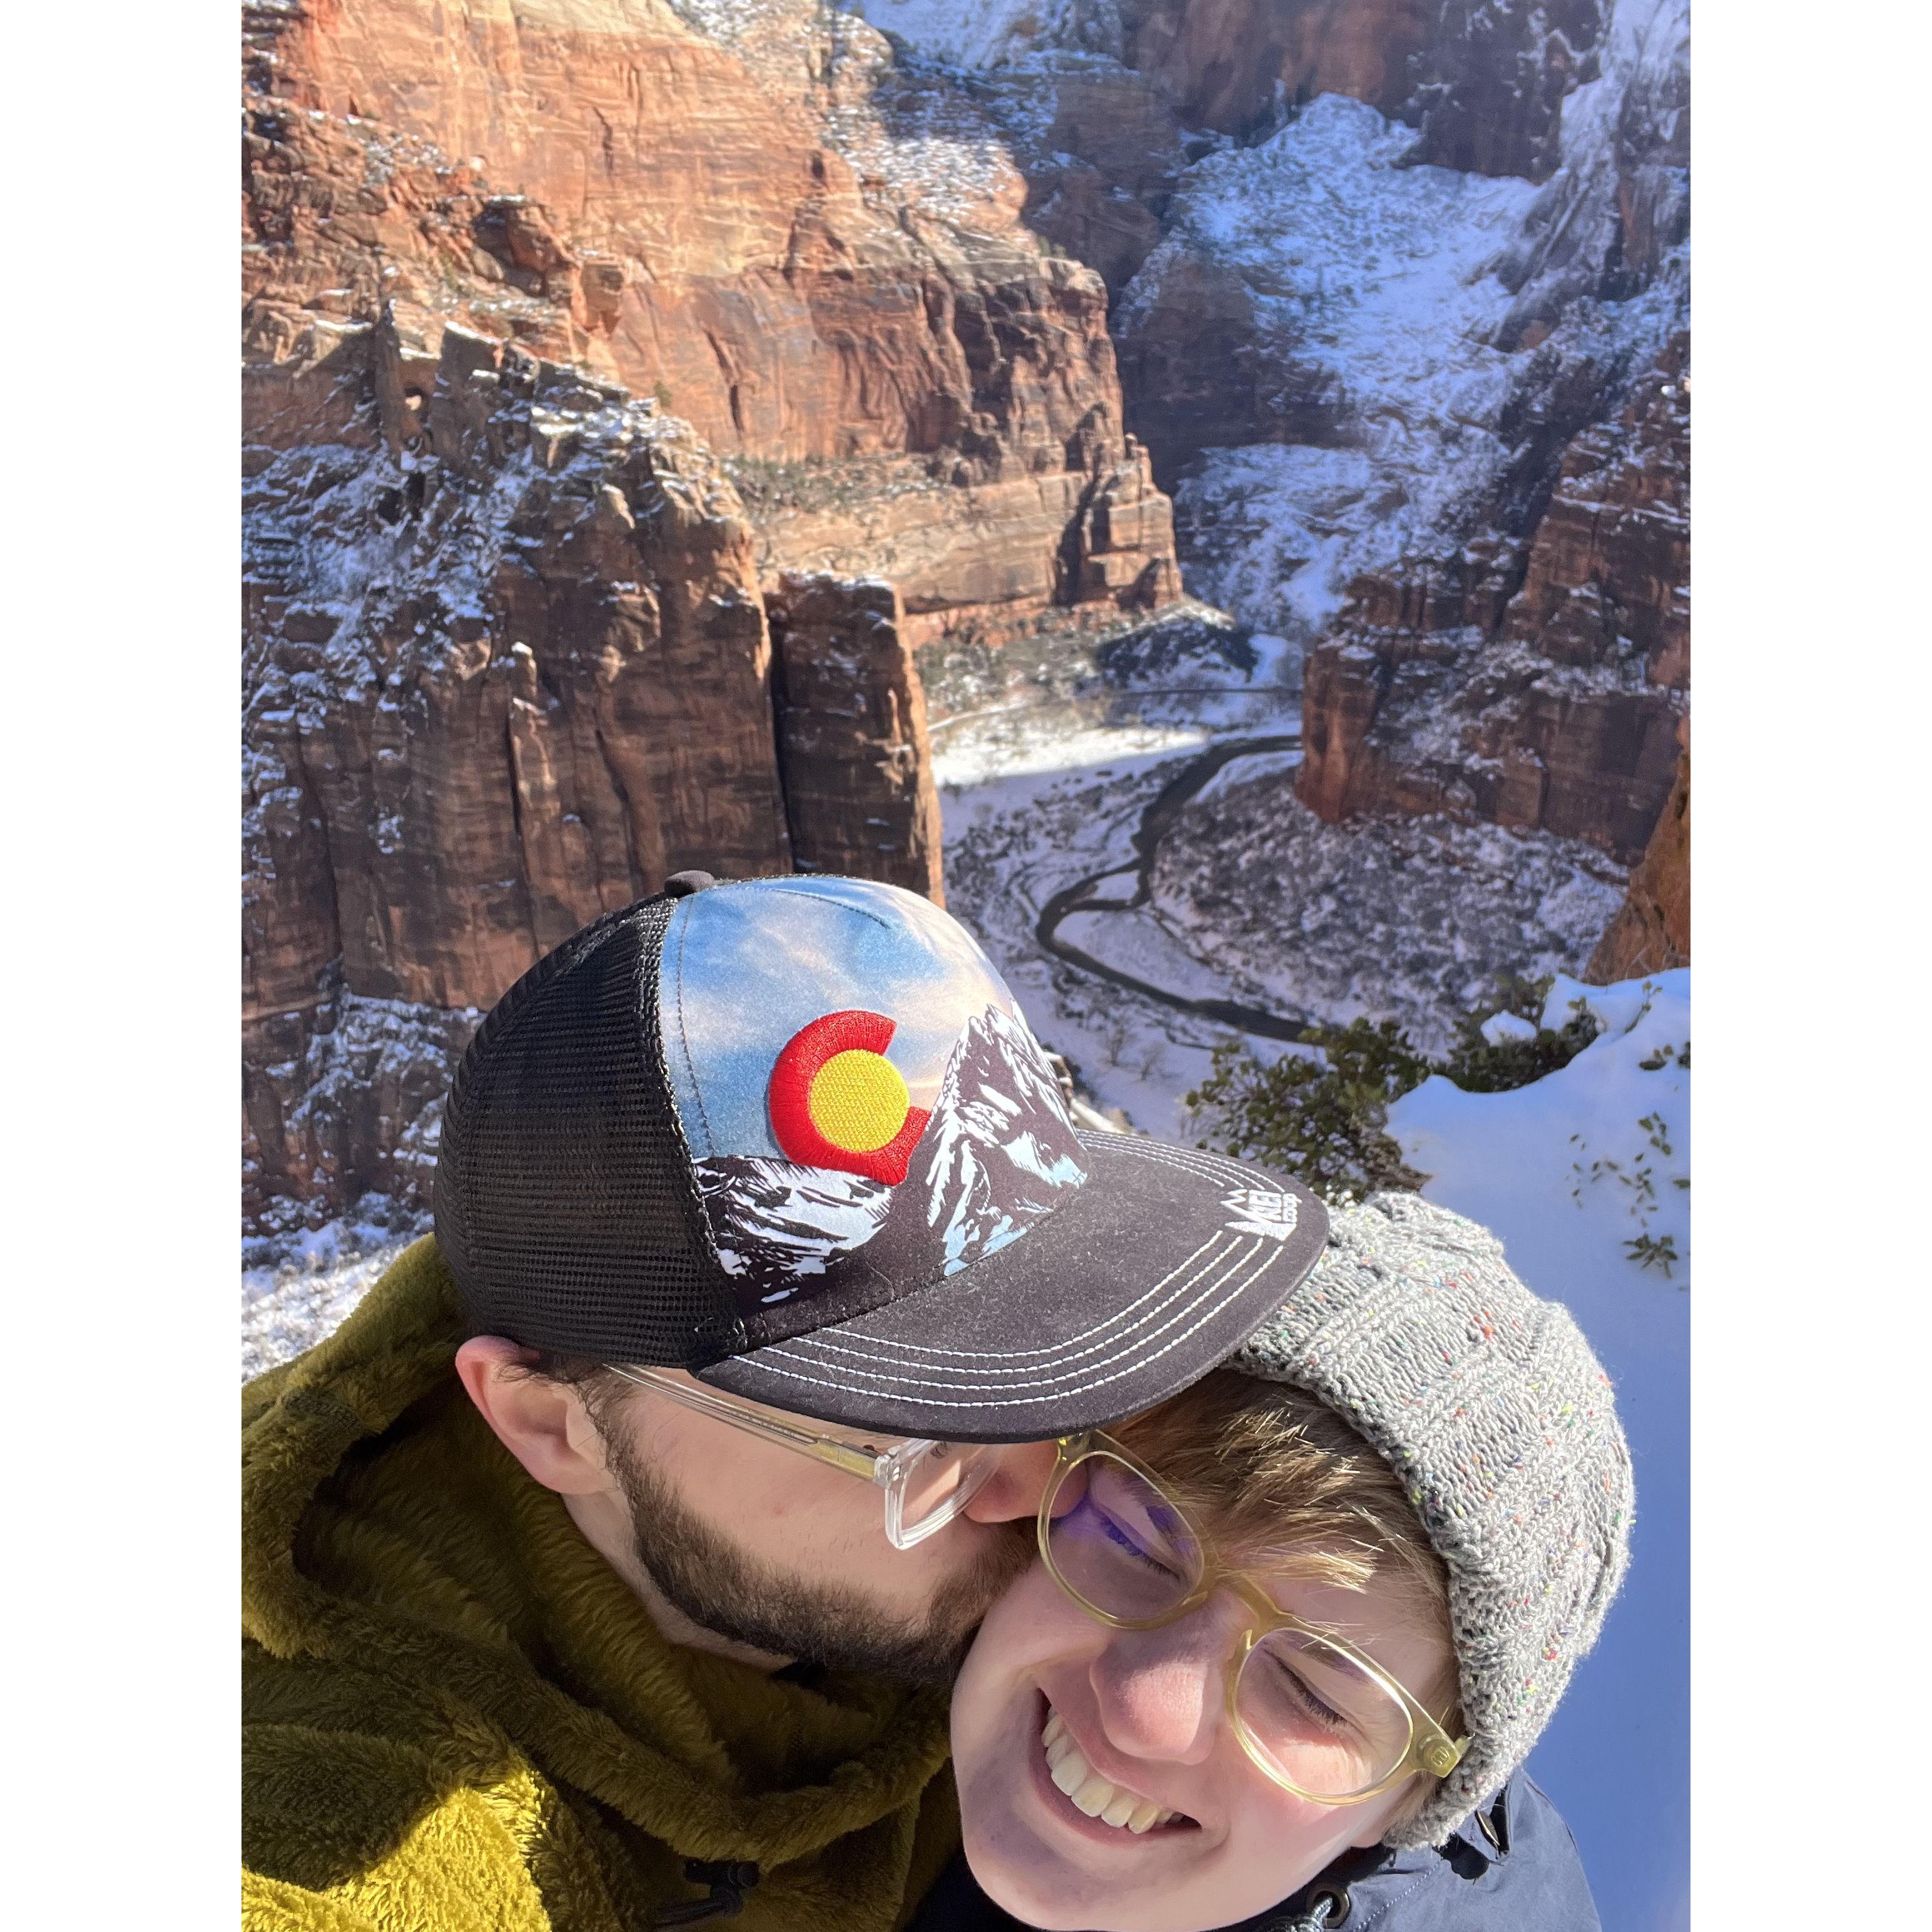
[914,1194,1632,1932]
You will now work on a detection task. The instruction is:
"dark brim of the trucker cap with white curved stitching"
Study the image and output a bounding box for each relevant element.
[698,1134,1327,1441]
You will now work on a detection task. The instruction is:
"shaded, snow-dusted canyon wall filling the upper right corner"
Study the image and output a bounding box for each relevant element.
[863,0,1689,860]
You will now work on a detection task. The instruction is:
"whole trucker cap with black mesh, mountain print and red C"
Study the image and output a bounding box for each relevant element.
[435,873,1327,1441]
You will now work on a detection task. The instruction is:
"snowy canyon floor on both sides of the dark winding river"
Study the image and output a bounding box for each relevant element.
[941,722,1625,1138]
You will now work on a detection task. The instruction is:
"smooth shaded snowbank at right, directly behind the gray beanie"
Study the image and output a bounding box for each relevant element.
[1389,970,1690,1932]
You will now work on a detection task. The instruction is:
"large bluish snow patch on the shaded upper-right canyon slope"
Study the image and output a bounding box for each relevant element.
[1136,94,1536,636]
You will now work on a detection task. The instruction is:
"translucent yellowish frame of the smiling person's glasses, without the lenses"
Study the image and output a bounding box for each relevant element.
[1035,1430,1468,1804]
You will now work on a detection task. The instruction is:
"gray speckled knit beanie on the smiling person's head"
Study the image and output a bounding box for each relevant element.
[1227,1194,1632,1845]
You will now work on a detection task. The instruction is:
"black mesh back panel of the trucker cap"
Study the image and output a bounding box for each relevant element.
[437,898,742,1368]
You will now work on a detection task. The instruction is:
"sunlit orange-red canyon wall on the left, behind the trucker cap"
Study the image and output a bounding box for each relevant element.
[242,0,1179,1243]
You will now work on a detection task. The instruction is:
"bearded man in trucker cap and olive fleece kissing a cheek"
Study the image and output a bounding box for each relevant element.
[243,873,1327,1932]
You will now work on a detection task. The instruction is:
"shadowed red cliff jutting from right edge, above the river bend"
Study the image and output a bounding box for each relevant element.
[1298,338,1690,860]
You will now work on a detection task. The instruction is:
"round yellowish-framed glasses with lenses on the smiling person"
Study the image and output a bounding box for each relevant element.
[1039,1431,1468,1804]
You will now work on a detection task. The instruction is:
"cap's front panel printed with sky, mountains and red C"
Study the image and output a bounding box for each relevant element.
[659,877,1085,1310]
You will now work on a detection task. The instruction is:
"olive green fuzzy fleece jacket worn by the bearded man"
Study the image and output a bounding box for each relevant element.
[242,1240,958,1932]
